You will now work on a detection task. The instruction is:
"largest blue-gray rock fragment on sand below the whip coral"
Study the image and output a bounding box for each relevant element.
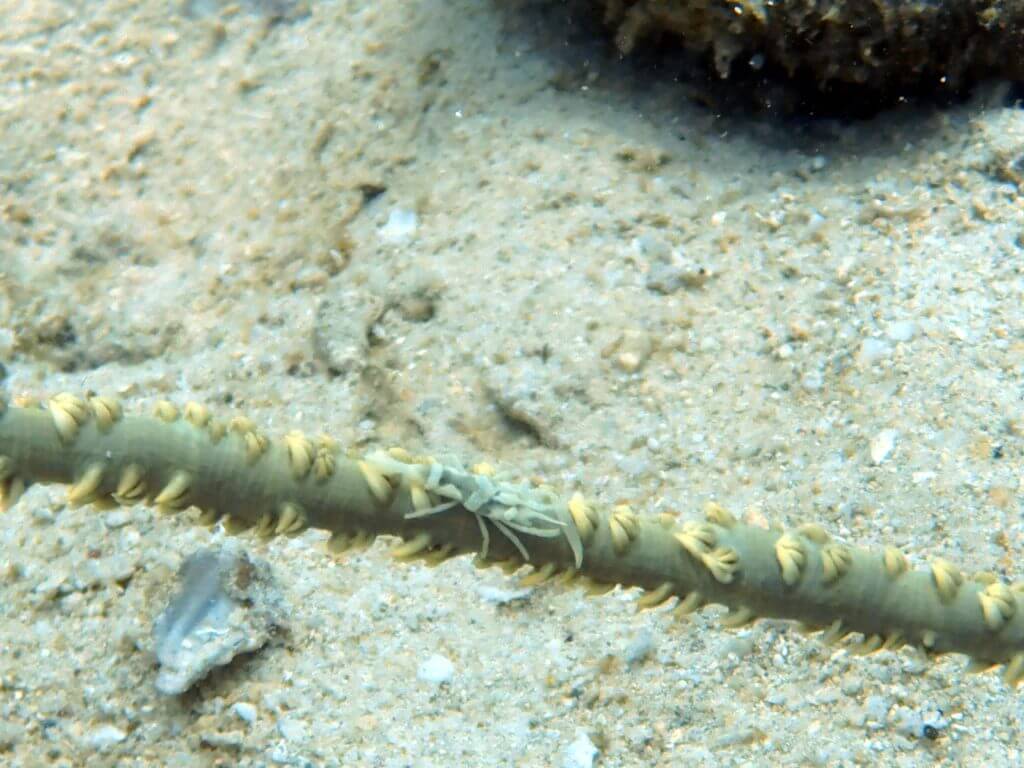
[154,545,285,695]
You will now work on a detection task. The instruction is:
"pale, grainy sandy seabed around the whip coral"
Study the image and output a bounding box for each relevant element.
[0,0,1024,768]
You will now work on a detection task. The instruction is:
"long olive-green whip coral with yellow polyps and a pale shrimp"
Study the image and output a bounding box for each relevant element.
[0,394,1024,685]
